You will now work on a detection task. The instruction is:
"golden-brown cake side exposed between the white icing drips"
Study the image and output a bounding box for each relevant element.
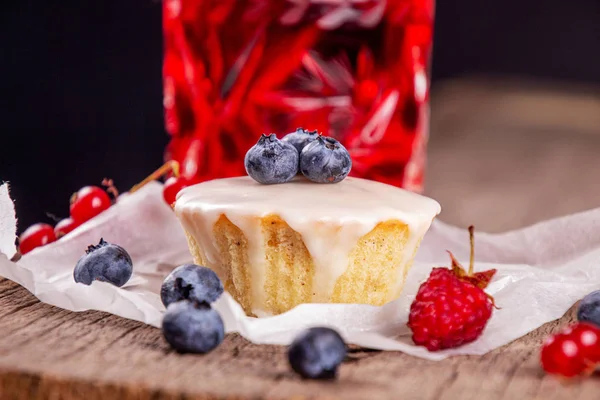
[188,215,414,314]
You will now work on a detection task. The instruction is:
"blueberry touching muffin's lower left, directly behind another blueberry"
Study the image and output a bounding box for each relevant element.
[160,264,223,307]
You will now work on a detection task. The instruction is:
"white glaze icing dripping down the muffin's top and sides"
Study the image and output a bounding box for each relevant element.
[175,177,440,315]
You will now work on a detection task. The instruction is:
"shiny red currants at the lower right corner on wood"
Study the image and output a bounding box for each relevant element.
[541,322,600,378]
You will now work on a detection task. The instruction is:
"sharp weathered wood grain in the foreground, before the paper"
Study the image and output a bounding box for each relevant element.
[0,280,600,400]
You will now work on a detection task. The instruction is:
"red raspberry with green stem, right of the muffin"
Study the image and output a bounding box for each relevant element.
[408,227,496,351]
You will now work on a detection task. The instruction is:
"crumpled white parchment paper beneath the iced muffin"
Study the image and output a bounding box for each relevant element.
[0,182,600,360]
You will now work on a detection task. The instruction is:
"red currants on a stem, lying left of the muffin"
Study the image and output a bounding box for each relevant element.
[19,161,199,254]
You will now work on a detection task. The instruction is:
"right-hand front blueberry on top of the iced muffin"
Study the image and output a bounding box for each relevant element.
[300,136,352,183]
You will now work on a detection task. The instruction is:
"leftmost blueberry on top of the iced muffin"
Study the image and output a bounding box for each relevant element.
[244,133,298,184]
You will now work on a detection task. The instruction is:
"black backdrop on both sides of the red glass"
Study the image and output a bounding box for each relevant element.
[0,0,600,231]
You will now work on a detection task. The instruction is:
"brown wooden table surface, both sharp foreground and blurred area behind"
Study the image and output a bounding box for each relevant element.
[0,82,600,400]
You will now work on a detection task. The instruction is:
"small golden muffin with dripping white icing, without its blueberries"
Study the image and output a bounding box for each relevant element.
[175,177,440,316]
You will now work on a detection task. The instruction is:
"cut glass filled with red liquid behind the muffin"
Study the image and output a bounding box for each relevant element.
[163,0,433,191]
